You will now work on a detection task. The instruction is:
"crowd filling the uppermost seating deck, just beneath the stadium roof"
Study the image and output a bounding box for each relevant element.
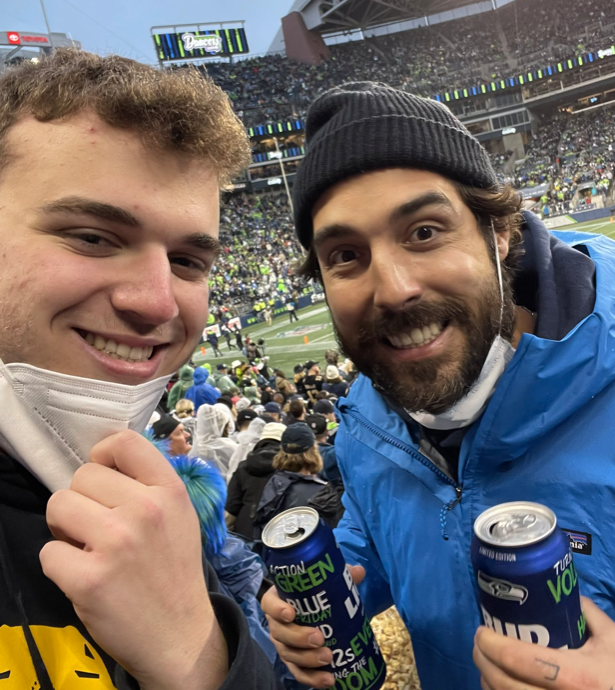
[202,0,615,126]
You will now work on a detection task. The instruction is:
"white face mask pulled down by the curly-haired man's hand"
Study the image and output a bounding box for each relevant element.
[0,360,171,491]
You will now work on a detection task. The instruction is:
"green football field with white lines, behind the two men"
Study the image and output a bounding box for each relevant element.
[194,218,615,378]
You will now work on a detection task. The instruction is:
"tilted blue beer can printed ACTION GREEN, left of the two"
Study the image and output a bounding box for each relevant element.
[262,507,386,690]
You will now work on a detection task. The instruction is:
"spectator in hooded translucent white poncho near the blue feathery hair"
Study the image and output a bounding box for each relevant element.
[191,404,238,479]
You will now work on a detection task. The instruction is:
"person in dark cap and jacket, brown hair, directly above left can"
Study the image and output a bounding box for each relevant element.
[254,422,344,540]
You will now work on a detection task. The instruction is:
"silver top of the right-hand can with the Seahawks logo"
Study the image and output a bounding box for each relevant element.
[474,501,557,547]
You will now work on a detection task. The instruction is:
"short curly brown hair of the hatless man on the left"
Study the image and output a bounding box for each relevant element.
[0,48,251,186]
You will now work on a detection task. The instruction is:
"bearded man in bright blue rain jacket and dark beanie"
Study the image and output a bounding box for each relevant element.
[264,82,615,690]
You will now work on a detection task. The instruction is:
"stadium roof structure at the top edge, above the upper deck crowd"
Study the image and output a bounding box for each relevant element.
[292,0,476,34]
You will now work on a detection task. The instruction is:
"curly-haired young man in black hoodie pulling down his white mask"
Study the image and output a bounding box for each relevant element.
[0,49,278,690]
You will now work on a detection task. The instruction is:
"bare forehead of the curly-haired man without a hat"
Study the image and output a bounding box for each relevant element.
[0,112,219,226]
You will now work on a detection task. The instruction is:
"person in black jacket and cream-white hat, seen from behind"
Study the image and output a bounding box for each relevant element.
[226,422,286,541]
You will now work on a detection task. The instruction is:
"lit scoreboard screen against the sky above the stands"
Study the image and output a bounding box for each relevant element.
[153,27,249,62]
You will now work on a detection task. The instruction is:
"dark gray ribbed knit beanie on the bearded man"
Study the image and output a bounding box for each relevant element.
[293,81,497,249]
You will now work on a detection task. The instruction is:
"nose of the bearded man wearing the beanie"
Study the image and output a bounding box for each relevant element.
[370,249,423,311]
